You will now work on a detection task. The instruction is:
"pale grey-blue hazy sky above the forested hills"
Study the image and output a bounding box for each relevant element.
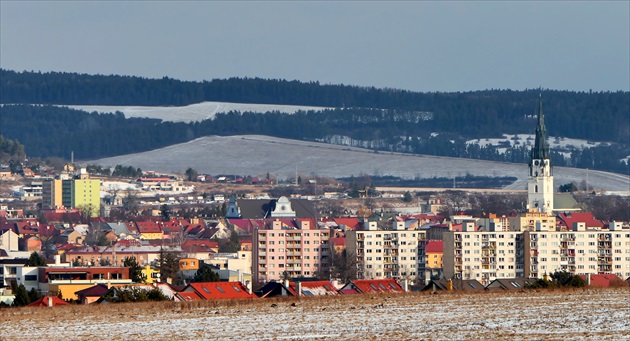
[0,0,630,91]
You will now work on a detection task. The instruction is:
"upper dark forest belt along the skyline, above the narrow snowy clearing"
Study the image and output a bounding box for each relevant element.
[0,70,630,144]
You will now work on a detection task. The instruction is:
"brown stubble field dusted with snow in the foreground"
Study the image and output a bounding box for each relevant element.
[0,288,630,341]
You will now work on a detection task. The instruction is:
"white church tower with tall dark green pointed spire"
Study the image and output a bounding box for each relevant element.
[527,95,554,214]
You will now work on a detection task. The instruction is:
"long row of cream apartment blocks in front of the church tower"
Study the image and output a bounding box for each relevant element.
[444,222,630,284]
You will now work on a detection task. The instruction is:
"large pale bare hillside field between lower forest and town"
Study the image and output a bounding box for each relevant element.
[88,135,630,195]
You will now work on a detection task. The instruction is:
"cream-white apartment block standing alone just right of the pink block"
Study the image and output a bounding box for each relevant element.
[346,222,425,281]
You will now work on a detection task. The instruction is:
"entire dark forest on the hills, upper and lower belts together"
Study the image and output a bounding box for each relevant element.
[0,70,630,174]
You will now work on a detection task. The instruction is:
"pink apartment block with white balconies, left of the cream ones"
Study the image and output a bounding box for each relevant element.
[252,219,331,282]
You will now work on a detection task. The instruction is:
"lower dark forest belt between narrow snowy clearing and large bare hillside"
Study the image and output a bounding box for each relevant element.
[0,105,630,177]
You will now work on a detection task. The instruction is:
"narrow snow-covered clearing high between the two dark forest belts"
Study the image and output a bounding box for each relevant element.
[68,102,328,122]
